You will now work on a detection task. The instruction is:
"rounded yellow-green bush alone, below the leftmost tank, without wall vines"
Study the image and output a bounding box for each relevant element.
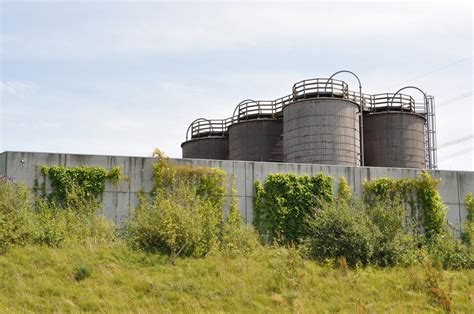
[127,184,222,261]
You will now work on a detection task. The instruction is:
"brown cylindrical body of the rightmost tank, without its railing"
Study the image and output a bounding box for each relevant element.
[364,111,426,169]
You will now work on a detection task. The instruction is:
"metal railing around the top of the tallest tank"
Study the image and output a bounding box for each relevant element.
[293,78,349,100]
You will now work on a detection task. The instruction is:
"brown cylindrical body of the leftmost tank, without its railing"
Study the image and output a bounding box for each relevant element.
[181,136,229,160]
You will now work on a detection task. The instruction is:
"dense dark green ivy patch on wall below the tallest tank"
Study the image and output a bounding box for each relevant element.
[254,173,334,244]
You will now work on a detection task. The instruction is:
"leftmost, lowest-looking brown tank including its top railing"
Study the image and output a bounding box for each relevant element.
[181,118,229,160]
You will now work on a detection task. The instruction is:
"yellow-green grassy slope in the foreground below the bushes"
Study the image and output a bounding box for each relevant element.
[0,243,474,313]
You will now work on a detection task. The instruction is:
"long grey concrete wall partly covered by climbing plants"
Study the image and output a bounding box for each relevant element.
[0,152,474,236]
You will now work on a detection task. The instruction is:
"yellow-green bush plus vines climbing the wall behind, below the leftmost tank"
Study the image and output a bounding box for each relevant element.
[127,153,257,263]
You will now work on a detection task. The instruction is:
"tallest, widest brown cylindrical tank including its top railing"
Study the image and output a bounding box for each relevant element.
[283,79,360,166]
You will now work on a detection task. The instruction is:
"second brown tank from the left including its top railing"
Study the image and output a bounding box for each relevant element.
[229,100,283,162]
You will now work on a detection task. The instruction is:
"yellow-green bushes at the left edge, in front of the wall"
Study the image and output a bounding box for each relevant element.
[0,177,116,252]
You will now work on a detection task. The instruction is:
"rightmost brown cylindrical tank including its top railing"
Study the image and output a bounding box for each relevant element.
[364,94,426,169]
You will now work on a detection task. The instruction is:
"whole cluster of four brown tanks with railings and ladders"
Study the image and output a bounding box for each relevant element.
[181,70,437,169]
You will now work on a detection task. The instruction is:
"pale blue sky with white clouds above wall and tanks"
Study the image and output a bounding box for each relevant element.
[0,0,474,171]
